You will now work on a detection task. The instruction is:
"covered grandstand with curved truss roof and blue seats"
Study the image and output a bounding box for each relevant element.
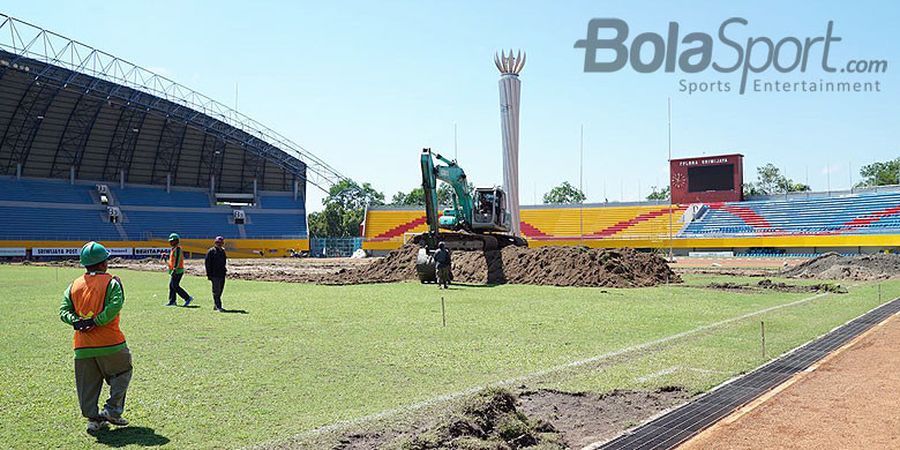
[0,15,343,256]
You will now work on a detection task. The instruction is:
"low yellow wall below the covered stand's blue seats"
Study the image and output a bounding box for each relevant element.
[0,239,309,258]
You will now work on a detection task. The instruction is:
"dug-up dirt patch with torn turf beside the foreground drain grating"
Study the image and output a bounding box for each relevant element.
[330,386,691,450]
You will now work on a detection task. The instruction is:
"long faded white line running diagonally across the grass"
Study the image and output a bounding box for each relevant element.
[250,292,828,448]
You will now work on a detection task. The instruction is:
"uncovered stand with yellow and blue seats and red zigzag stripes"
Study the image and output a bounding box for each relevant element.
[363,186,900,255]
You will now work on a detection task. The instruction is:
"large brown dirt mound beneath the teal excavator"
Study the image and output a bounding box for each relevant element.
[320,245,681,287]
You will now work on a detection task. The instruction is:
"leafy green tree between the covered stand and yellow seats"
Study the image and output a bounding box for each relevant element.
[308,179,384,237]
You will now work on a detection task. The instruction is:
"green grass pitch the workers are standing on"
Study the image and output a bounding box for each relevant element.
[0,265,900,448]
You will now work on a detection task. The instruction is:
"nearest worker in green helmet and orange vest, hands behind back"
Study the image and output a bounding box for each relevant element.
[59,242,132,433]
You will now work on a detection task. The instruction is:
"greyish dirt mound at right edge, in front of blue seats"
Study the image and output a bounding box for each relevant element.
[781,253,900,281]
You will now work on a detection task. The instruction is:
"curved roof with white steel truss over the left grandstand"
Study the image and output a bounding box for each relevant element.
[0,14,343,192]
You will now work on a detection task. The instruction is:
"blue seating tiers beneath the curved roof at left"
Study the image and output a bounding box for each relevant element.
[0,178,308,241]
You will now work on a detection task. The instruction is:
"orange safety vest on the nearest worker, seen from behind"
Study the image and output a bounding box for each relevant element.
[69,273,125,350]
